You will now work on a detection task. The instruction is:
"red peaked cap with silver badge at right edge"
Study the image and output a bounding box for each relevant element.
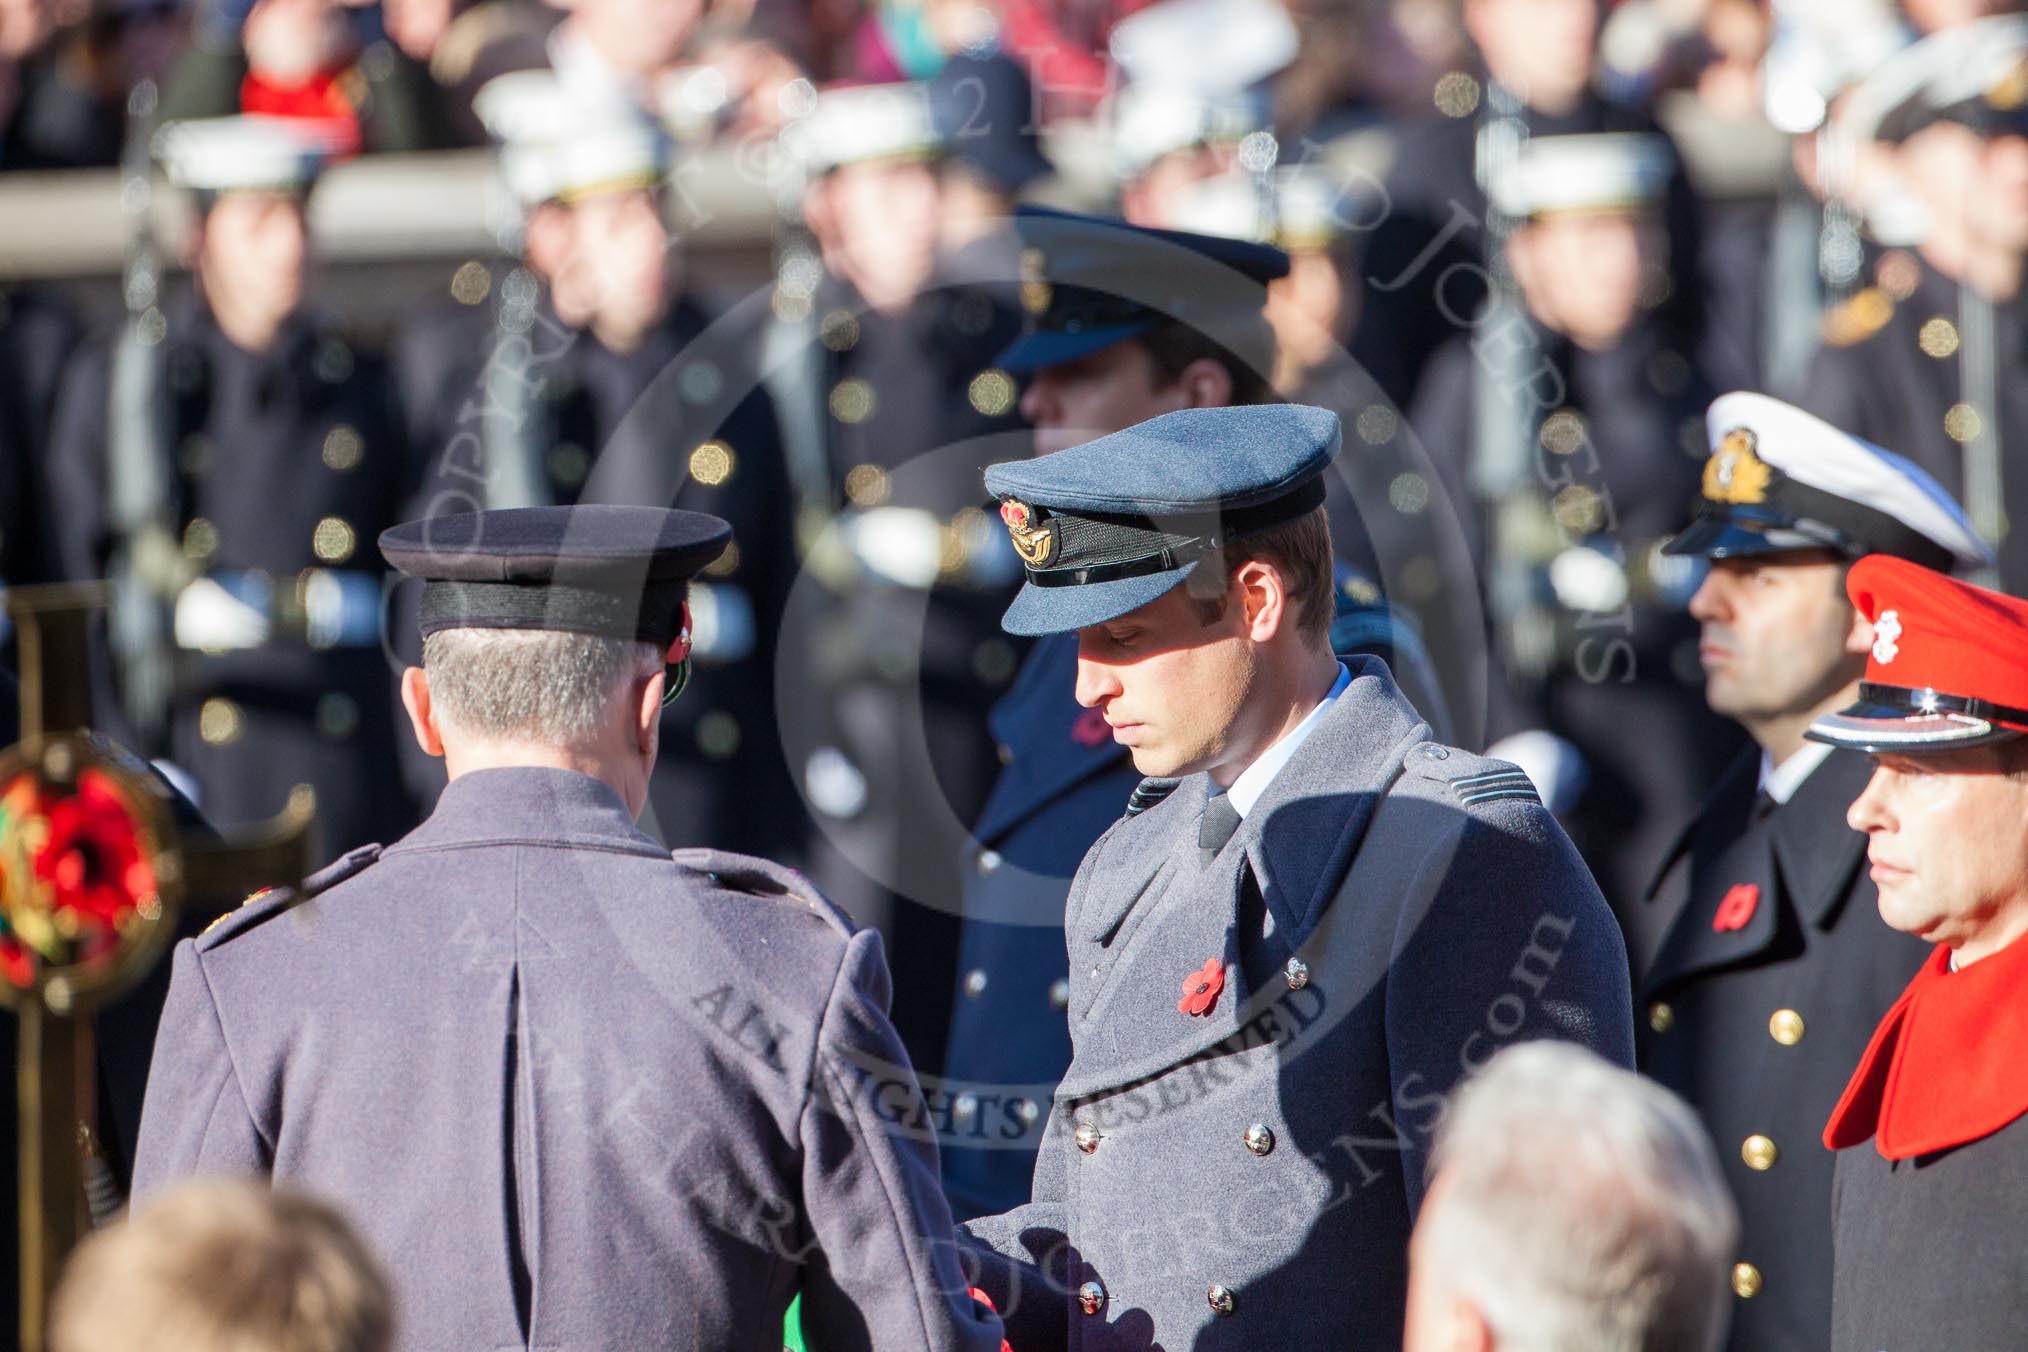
[1809,553,2028,752]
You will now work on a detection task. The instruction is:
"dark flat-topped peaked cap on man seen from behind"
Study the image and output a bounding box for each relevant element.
[379,505,732,647]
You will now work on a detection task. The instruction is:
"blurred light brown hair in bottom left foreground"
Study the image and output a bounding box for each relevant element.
[49,1180,393,1352]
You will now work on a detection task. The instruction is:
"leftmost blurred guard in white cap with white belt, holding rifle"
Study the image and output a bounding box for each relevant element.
[47,118,414,855]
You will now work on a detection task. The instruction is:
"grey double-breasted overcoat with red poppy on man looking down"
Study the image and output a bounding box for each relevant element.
[965,659,1633,1352]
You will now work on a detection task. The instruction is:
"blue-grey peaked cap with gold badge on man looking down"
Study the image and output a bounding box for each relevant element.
[986,403,1343,634]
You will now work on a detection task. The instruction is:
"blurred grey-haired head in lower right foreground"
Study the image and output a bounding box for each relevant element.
[1403,1042,1738,1352]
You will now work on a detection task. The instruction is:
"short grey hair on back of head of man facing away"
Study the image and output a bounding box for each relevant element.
[422,628,663,746]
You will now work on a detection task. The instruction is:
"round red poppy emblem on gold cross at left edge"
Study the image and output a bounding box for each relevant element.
[0,768,162,991]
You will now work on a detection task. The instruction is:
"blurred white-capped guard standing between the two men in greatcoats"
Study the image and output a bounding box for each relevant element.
[763,85,1026,1064]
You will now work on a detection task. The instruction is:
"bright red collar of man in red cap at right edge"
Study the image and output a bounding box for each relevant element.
[1823,941,2028,1159]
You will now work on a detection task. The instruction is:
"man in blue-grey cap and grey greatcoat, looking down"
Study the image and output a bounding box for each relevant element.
[965,405,1633,1352]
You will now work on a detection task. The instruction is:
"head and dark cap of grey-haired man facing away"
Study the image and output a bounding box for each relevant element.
[379,507,732,817]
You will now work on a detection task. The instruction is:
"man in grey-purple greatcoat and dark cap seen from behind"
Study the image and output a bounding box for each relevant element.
[136,507,1000,1352]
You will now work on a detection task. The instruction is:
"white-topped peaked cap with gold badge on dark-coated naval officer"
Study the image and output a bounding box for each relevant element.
[1665,391,1994,574]
